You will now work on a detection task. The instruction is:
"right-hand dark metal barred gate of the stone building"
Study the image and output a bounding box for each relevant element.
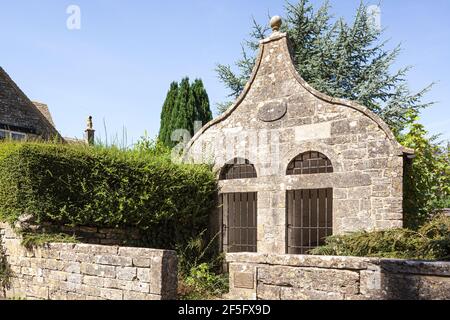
[286,189,333,254]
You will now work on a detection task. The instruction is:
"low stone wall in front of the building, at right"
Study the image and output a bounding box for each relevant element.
[227,253,450,300]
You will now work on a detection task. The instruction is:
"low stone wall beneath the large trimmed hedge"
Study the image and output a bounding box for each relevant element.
[0,224,177,300]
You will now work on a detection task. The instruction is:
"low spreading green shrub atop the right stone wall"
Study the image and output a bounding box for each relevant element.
[312,216,450,261]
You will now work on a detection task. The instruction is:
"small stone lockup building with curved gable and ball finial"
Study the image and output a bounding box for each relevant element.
[185,17,413,254]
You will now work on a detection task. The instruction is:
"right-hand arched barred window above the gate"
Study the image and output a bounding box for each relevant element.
[287,151,333,175]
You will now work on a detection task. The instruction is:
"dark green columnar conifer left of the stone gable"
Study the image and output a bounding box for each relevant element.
[159,78,212,147]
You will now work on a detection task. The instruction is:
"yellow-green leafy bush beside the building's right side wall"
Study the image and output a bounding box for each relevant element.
[399,114,450,228]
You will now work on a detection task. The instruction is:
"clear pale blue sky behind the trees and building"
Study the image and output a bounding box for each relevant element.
[0,0,450,143]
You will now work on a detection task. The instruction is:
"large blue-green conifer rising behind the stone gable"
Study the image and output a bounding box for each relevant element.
[217,0,430,133]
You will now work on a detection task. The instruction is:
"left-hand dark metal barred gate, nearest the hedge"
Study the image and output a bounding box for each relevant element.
[220,192,258,252]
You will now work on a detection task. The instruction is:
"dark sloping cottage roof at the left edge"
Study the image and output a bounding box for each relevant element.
[0,67,62,139]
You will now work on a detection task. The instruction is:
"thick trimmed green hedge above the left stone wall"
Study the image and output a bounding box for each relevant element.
[0,142,217,246]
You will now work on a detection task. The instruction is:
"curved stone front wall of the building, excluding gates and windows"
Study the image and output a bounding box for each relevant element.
[185,20,413,254]
